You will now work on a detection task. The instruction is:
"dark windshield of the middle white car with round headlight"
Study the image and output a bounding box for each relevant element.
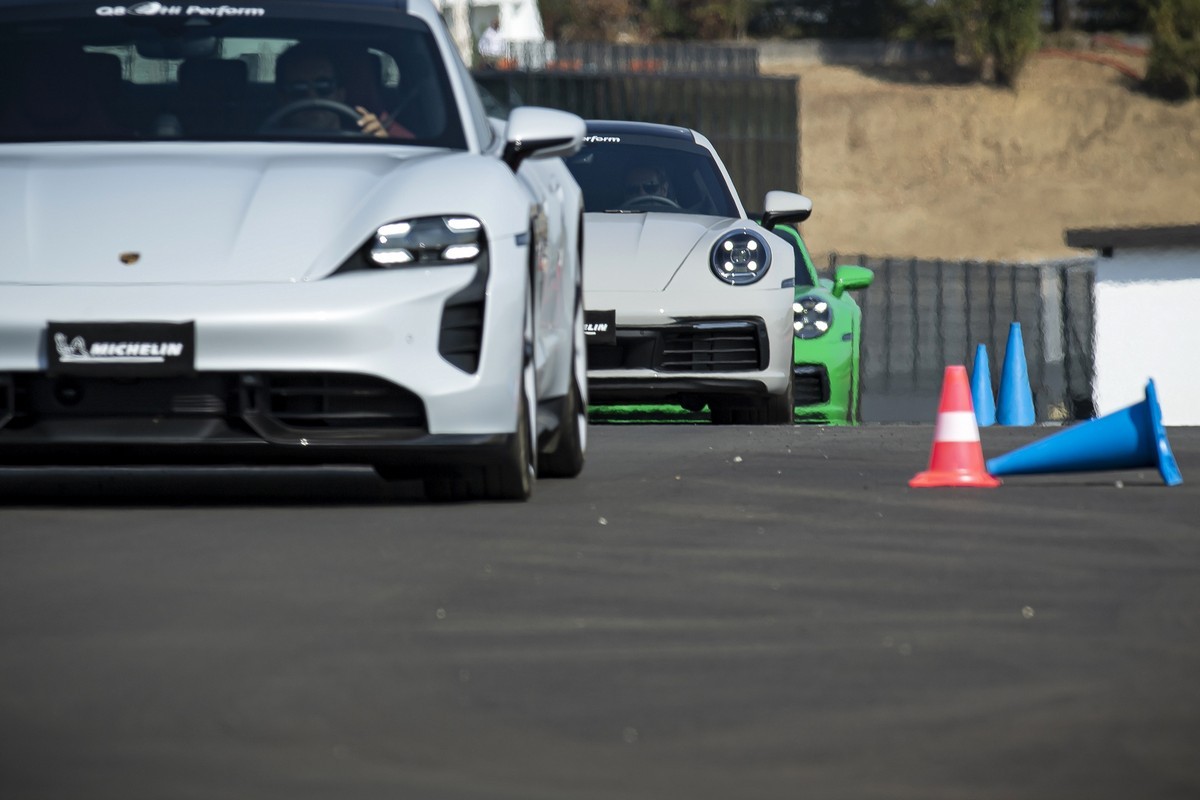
[566,134,739,217]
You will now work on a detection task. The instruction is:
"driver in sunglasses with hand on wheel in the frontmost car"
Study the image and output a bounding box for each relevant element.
[275,42,389,138]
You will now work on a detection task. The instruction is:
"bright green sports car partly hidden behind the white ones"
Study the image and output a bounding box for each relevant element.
[775,225,875,425]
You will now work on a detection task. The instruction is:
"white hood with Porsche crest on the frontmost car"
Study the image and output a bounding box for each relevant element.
[0,144,472,284]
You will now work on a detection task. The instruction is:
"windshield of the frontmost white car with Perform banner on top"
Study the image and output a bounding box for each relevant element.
[0,2,466,149]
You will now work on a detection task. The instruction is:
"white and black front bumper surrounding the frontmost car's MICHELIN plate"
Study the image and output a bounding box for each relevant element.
[0,260,524,464]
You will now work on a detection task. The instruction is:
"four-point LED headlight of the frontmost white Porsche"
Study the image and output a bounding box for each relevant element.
[367,217,487,269]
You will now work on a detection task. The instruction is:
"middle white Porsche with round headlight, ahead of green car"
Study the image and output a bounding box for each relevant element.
[566,120,812,425]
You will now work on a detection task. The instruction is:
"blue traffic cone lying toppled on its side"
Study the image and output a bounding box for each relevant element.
[988,380,1183,486]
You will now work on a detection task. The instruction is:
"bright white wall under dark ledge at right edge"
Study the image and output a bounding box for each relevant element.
[1094,247,1200,426]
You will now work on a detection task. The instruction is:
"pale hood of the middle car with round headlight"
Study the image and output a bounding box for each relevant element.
[583,212,752,291]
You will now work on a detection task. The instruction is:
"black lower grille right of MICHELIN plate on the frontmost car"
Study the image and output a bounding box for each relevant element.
[258,373,425,429]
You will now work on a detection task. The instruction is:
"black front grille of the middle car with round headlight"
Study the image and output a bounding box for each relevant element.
[588,319,769,373]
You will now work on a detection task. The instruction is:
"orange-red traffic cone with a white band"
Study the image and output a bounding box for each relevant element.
[908,365,1000,488]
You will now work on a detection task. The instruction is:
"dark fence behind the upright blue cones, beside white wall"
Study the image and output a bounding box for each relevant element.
[829,253,1094,422]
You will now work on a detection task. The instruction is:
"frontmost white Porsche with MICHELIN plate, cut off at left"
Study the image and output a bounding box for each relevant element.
[0,0,588,499]
